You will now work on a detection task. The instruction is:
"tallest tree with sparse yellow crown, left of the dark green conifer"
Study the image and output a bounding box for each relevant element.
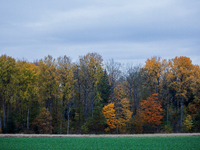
[79,53,103,121]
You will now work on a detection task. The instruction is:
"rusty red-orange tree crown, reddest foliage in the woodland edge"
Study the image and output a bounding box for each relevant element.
[140,93,163,125]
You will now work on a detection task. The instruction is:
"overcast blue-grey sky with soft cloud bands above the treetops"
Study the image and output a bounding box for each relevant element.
[0,0,200,65]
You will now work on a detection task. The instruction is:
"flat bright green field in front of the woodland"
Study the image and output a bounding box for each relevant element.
[0,136,200,150]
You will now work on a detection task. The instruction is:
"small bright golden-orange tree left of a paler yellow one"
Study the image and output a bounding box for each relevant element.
[103,103,117,132]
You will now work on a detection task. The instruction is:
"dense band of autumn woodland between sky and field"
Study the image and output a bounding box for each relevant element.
[0,53,200,134]
